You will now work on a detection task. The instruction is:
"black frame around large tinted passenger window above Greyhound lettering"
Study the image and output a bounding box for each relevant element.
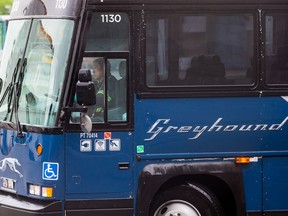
[137,5,288,98]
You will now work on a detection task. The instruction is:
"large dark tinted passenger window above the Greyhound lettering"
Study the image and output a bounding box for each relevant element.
[146,13,255,87]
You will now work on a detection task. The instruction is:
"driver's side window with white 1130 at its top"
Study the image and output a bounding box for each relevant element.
[74,12,129,123]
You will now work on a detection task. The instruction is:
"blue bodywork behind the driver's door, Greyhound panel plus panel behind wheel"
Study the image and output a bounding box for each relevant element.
[135,97,288,212]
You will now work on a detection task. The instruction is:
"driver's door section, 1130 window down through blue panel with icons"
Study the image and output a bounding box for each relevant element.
[66,11,133,198]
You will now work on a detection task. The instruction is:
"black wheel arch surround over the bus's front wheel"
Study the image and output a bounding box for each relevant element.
[136,162,245,216]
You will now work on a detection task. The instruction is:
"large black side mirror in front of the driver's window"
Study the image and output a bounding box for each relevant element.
[76,69,96,106]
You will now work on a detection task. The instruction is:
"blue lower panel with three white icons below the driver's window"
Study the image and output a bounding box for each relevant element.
[66,132,133,199]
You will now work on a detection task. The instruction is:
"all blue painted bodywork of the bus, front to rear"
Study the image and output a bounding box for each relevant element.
[0,97,288,211]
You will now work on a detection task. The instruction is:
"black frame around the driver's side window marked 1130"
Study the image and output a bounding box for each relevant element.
[66,6,134,131]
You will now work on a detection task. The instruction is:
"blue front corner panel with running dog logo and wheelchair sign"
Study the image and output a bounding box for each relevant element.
[0,132,65,200]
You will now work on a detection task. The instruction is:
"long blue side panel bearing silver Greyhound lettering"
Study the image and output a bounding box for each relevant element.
[136,97,288,157]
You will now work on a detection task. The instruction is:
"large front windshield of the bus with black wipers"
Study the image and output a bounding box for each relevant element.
[0,19,74,126]
